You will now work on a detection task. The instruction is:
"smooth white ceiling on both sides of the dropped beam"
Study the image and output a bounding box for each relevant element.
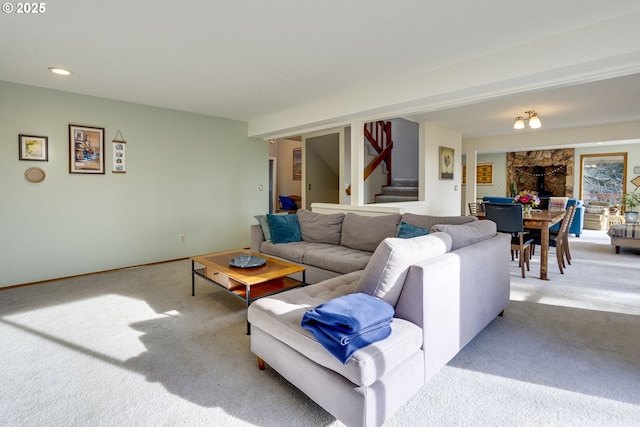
[0,0,640,136]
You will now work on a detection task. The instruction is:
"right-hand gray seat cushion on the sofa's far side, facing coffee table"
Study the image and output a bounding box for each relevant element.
[302,245,372,274]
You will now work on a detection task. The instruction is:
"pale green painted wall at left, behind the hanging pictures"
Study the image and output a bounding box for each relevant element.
[0,82,268,289]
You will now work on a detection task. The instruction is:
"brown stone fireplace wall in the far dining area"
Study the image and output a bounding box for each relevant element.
[506,148,575,197]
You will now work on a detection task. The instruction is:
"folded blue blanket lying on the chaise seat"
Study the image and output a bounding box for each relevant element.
[301,293,394,364]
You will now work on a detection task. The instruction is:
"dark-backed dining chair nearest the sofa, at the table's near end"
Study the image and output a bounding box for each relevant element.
[484,203,533,278]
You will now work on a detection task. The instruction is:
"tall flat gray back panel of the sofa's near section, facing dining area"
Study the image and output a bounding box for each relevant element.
[396,233,511,381]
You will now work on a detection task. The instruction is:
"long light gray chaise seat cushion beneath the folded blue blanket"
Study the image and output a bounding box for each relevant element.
[247,271,422,387]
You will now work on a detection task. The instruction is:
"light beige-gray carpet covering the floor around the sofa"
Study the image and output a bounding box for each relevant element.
[0,231,640,426]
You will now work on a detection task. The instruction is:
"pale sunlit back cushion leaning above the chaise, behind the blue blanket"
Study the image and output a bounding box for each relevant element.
[358,233,452,307]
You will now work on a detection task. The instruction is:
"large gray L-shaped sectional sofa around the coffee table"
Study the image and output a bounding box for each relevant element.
[247,213,510,426]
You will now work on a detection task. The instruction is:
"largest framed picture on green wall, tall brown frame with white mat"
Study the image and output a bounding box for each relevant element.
[69,125,104,174]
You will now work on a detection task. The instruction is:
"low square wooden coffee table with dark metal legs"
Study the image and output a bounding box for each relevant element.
[191,249,306,335]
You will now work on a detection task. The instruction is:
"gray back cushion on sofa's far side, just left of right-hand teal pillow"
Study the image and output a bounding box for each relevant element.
[340,212,402,252]
